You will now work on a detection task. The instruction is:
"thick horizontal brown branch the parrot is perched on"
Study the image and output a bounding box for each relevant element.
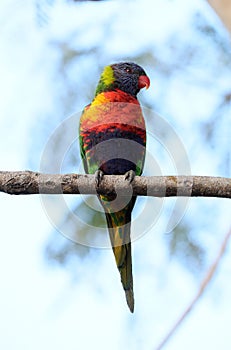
[0,171,231,198]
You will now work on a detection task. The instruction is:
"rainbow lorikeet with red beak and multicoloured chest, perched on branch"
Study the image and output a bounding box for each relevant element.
[79,62,150,312]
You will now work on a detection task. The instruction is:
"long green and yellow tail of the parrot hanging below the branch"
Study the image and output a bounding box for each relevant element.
[101,197,136,312]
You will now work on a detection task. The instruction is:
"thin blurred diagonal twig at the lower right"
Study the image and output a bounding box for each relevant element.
[156,229,231,350]
